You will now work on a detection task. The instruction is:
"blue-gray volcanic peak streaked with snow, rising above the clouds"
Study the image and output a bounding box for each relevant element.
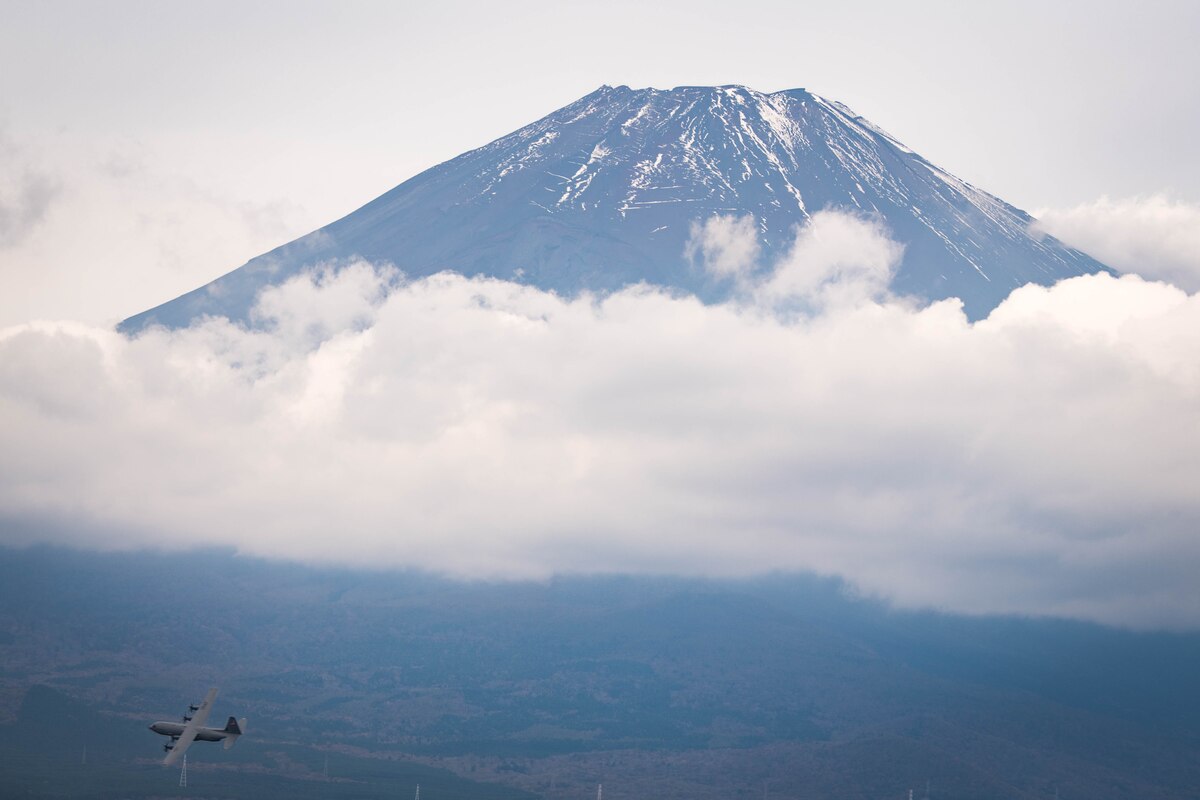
[120,86,1108,332]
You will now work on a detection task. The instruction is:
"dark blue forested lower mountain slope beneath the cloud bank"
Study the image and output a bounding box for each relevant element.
[7,548,1200,800]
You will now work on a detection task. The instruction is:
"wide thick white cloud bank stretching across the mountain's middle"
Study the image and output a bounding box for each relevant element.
[0,219,1200,627]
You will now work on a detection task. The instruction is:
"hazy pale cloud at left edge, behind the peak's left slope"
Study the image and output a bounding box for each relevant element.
[0,131,312,325]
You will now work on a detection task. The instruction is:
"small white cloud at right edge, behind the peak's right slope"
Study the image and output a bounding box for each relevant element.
[1033,194,1200,291]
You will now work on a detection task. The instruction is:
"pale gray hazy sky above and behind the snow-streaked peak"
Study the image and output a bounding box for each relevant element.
[0,1,1200,324]
